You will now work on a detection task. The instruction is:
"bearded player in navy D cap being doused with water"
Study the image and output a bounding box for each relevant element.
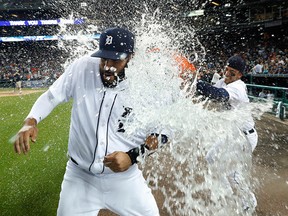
[14,28,167,216]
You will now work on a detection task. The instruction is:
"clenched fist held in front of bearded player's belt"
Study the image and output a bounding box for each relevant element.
[103,151,131,172]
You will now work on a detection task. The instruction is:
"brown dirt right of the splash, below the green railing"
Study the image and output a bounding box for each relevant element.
[253,114,288,216]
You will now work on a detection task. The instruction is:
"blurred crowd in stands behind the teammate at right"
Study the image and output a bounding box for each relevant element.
[198,31,288,76]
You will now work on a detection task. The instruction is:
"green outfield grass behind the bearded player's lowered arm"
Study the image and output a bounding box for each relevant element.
[0,93,71,216]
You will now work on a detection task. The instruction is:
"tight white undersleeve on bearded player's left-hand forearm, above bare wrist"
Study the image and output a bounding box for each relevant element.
[26,90,60,123]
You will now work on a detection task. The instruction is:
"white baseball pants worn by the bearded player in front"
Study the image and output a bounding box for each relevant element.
[57,160,159,216]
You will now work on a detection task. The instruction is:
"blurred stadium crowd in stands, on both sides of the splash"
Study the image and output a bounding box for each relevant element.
[0,36,288,86]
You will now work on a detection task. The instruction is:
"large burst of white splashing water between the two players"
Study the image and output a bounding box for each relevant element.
[59,8,270,215]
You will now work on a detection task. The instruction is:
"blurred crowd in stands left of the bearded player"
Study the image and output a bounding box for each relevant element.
[0,42,65,86]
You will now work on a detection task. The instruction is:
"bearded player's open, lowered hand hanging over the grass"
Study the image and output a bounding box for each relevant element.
[14,118,38,154]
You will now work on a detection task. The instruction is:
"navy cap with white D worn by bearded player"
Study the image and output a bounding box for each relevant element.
[91,28,134,60]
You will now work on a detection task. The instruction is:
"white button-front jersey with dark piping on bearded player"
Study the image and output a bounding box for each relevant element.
[49,57,147,174]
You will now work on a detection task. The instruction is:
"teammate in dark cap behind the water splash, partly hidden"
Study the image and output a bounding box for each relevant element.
[197,55,258,211]
